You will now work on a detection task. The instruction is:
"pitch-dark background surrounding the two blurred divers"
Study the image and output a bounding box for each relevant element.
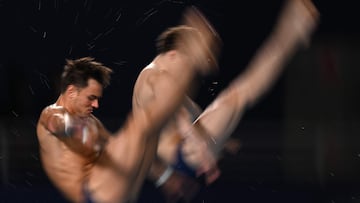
[0,0,360,203]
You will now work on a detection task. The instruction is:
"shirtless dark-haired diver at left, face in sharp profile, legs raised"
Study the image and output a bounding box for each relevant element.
[37,7,222,203]
